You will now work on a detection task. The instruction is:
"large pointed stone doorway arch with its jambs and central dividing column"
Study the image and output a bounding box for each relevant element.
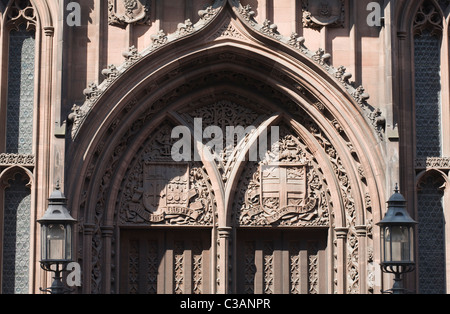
[66,1,386,293]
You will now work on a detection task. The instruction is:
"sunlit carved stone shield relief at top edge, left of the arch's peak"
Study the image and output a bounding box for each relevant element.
[108,0,151,26]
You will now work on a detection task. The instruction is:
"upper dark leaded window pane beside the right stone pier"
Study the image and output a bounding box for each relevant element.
[414,30,442,158]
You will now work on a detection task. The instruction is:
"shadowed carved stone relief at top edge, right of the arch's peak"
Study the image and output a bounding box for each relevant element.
[303,0,345,29]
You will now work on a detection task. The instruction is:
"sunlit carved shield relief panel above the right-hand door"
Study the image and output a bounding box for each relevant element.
[234,127,330,227]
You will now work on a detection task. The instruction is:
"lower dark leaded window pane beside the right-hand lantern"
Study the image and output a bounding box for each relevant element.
[417,175,446,294]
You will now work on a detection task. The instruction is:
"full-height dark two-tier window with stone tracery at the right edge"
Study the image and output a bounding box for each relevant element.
[413,0,449,294]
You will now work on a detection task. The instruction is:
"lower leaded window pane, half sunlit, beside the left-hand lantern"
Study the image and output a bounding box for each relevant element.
[2,174,31,294]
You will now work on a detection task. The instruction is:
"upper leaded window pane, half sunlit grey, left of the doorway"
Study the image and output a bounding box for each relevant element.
[6,24,35,155]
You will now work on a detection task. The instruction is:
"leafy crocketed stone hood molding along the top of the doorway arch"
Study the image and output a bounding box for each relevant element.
[69,0,385,140]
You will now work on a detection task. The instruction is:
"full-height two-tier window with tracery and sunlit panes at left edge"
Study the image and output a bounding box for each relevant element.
[0,0,37,294]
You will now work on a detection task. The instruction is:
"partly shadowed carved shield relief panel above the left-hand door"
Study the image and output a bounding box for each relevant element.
[119,124,214,225]
